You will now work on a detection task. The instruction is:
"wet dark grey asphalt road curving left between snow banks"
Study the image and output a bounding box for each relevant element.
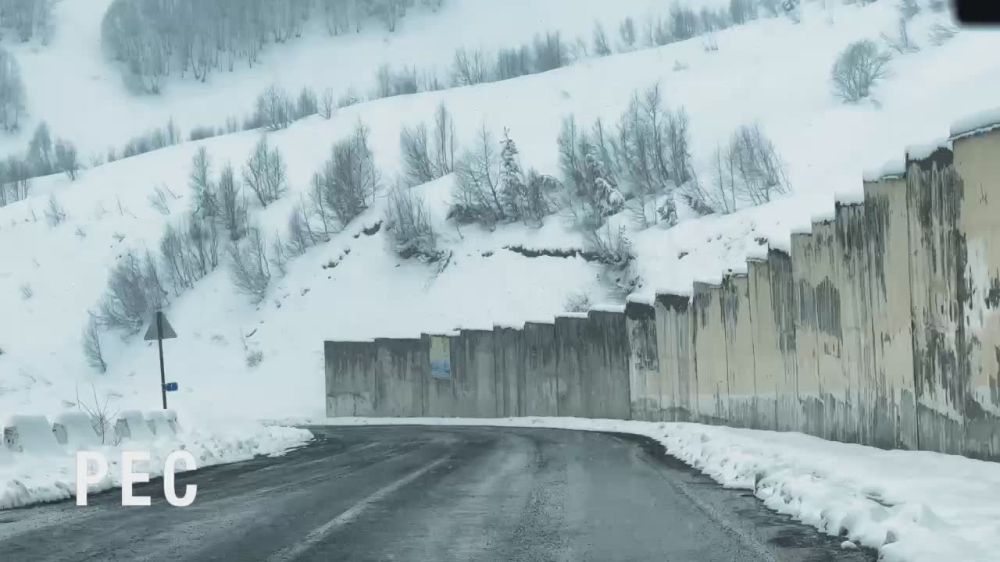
[0,427,875,562]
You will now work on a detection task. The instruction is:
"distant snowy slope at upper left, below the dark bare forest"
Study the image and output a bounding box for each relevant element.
[0,0,723,156]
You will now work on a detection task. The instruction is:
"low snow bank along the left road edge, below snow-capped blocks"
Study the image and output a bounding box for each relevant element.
[0,422,312,510]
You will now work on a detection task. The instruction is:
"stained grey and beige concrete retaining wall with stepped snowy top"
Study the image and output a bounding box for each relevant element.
[326,120,1000,458]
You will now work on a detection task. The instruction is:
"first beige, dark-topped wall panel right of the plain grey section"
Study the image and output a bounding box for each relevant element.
[625,301,669,421]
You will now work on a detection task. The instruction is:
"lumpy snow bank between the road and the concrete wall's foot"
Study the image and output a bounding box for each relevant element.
[311,418,1000,562]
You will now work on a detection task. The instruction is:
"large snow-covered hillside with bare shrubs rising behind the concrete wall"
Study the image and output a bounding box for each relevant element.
[0,0,1000,418]
